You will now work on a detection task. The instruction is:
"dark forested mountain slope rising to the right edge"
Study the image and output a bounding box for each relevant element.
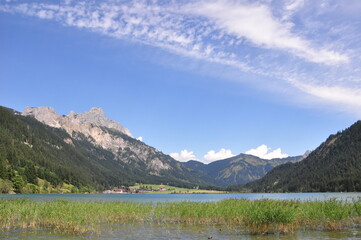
[244,121,361,192]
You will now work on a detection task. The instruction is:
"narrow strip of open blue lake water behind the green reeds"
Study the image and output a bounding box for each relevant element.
[0,193,361,202]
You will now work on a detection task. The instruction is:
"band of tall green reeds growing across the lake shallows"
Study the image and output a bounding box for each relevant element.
[0,200,361,234]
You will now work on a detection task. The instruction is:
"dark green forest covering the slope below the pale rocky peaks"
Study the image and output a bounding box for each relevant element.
[0,107,200,193]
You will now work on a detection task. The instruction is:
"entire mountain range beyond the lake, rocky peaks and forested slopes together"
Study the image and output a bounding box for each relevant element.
[0,104,361,193]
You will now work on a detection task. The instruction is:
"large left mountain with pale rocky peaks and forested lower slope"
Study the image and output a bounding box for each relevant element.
[0,107,208,192]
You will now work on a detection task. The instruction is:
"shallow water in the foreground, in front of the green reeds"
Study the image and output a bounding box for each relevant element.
[0,224,361,240]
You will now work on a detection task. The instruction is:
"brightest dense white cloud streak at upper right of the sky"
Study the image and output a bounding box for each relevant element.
[187,1,348,65]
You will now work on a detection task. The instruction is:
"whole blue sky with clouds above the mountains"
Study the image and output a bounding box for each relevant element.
[0,0,361,163]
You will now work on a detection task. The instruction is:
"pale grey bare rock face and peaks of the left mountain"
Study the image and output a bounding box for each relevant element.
[22,107,172,172]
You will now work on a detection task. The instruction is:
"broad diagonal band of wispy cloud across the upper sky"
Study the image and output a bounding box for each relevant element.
[0,0,361,115]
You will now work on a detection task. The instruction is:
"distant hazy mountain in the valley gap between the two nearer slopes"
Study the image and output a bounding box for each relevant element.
[183,154,303,187]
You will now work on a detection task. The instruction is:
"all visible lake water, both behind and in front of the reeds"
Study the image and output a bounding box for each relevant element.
[0,193,361,240]
